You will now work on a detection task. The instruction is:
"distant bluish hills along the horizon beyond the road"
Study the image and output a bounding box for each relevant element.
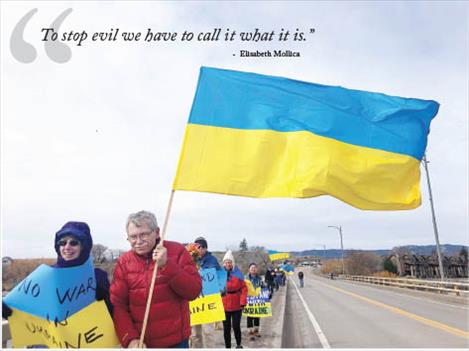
[290,244,469,259]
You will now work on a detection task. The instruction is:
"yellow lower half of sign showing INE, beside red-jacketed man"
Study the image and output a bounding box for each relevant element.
[189,293,225,326]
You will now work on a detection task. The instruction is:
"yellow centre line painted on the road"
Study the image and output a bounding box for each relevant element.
[317,281,469,339]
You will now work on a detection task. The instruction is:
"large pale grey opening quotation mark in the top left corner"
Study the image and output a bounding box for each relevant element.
[10,8,73,63]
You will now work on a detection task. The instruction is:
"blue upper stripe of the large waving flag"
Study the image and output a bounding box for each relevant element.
[189,67,439,160]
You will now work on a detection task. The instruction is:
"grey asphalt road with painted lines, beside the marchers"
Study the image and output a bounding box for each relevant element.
[282,268,469,348]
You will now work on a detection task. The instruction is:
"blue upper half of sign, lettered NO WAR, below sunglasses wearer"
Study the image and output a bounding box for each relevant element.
[3,258,96,322]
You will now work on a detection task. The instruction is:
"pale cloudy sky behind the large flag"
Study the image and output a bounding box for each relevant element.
[0,1,469,258]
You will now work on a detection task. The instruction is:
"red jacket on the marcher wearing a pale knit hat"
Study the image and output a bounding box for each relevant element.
[222,267,248,312]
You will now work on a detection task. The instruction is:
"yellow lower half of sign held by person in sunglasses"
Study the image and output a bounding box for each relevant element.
[8,301,119,349]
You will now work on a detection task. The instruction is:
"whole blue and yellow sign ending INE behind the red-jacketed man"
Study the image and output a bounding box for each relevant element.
[189,268,226,325]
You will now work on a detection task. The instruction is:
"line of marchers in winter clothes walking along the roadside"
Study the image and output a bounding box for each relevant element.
[2,211,304,348]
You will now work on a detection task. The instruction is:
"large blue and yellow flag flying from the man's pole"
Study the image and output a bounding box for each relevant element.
[173,67,439,210]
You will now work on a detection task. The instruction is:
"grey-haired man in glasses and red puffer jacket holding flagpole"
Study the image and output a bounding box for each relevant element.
[111,211,202,348]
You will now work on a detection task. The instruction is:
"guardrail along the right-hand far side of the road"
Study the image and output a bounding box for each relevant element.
[342,275,469,296]
